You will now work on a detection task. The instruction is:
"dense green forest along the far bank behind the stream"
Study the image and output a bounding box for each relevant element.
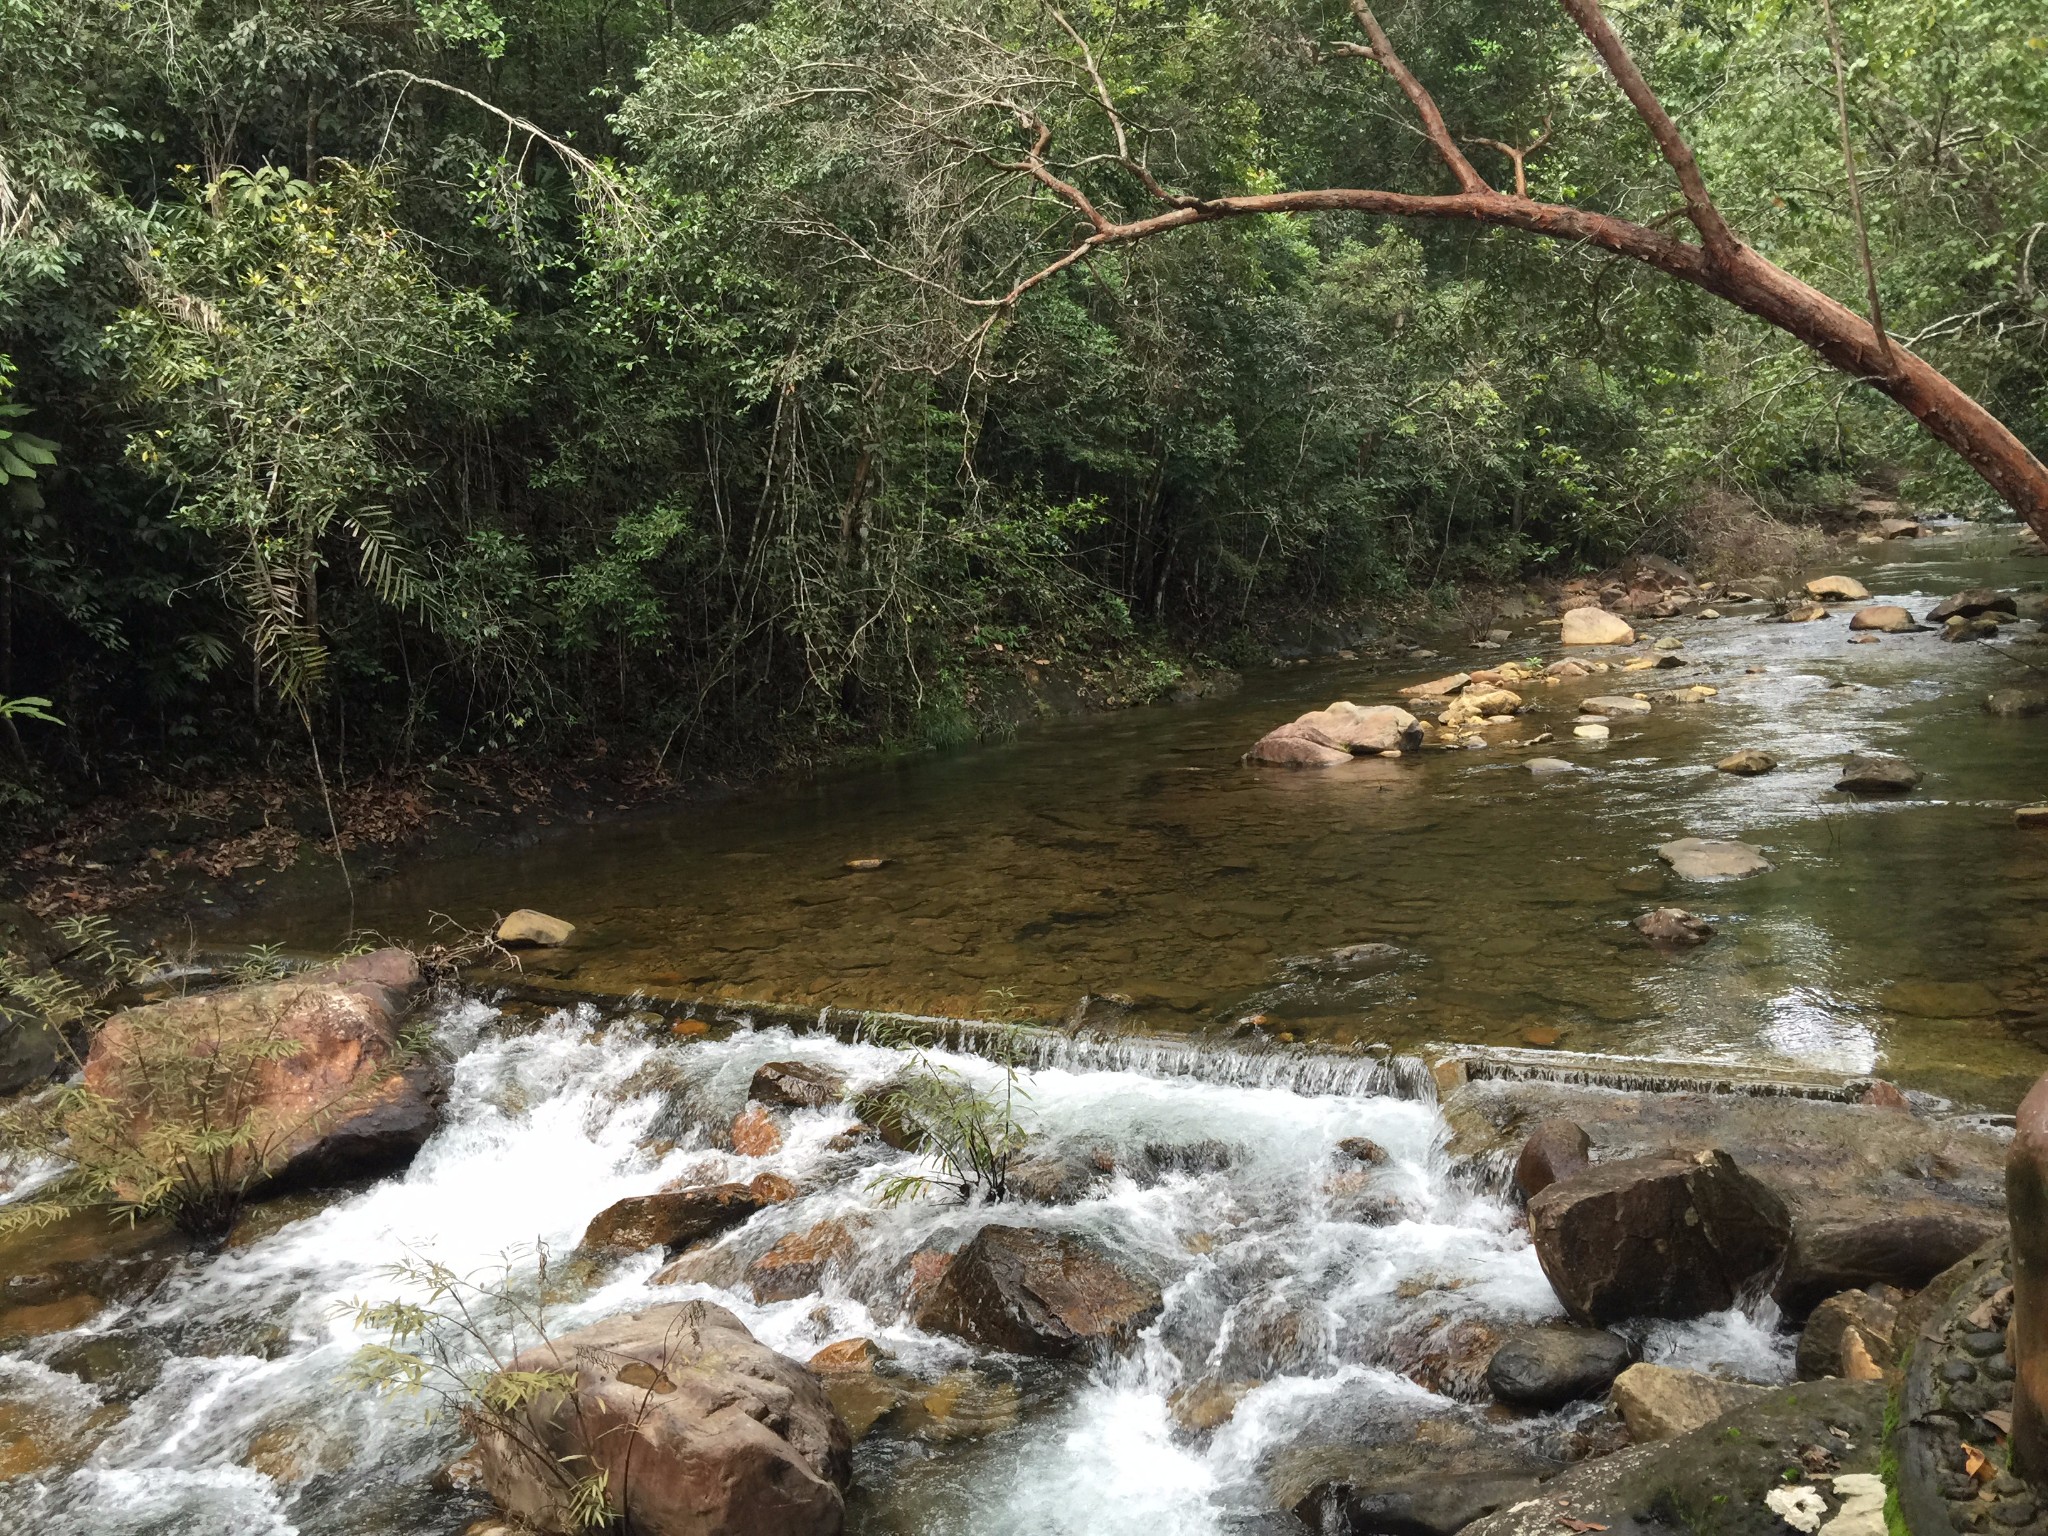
[0,0,2048,815]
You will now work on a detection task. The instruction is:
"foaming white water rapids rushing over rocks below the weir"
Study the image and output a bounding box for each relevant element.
[0,1001,1788,1536]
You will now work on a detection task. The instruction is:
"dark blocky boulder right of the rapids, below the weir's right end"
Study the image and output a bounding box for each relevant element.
[1530,1149,1792,1327]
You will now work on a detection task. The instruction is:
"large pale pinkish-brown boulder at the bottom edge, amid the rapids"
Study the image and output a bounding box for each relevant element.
[477,1300,852,1536]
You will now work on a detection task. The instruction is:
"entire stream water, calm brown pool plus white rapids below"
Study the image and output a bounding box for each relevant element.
[0,530,2048,1536]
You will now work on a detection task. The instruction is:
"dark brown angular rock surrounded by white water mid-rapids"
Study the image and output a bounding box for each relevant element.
[915,1225,1161,1358]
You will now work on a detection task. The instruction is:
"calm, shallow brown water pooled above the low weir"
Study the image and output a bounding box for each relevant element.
[242,532,2048,1108]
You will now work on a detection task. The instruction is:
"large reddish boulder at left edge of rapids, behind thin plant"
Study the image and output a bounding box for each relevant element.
[86,950,432,1192]
